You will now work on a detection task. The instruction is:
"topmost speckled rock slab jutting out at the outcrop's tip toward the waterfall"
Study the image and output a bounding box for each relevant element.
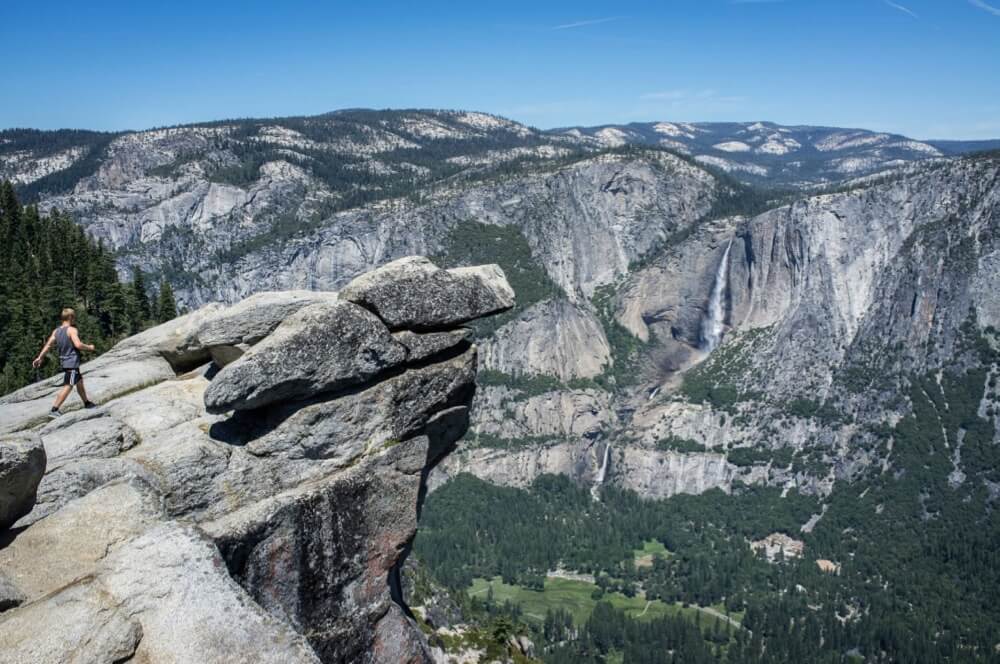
[340,256,514,330]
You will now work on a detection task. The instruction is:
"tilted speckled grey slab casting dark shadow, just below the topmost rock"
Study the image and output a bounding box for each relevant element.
[205,302,407,413]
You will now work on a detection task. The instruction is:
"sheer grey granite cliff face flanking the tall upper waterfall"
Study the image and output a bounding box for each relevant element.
[618,159,1000,396]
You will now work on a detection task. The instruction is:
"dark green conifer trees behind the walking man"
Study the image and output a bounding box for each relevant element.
[0,182,177,394]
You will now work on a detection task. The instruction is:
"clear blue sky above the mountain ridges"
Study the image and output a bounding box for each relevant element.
[0,0,1000,138]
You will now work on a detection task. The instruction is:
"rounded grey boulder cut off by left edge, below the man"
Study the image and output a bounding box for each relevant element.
[0,433,45,530]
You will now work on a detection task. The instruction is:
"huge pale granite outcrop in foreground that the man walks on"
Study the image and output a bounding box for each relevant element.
[0,258,509,663]
